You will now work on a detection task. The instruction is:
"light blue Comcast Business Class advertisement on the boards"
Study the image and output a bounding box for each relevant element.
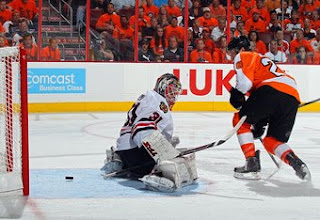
[28,68,86,94]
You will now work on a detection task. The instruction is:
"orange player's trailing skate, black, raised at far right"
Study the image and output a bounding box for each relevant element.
[286,152,311,181]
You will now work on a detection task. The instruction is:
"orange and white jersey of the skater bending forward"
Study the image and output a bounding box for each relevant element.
[234,52,300,102]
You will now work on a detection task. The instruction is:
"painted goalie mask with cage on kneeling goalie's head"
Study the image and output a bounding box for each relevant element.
[154,73,181,109]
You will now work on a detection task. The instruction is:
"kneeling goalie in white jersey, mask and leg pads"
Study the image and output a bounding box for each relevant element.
[101,73,197,192]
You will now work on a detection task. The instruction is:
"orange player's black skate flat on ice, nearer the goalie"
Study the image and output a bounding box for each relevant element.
[234,150,261,180]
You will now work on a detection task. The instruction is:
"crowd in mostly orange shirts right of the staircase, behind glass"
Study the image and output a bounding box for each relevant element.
[91,0,320,64]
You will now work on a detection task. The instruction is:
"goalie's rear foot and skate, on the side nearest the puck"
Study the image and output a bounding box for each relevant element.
[100,147,122,174]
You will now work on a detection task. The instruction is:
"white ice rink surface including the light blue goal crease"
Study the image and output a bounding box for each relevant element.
[0,112,320,220]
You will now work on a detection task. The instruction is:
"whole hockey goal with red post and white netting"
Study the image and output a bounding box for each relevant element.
[0,47,29,195]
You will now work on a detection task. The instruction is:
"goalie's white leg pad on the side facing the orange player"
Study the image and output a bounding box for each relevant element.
[157,153,198,189]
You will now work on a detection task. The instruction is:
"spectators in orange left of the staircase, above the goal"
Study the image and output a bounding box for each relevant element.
[0,0,60,61]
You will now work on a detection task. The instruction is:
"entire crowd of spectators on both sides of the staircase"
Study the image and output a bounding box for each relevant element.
[0,0,320,64]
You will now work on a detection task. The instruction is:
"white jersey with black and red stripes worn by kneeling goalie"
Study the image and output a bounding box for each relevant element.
[117,90,173,151]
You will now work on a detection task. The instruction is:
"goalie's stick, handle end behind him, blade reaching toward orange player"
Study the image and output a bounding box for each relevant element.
[101,116,247,179]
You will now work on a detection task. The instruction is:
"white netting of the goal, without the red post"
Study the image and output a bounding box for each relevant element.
[0,47,23,193]
